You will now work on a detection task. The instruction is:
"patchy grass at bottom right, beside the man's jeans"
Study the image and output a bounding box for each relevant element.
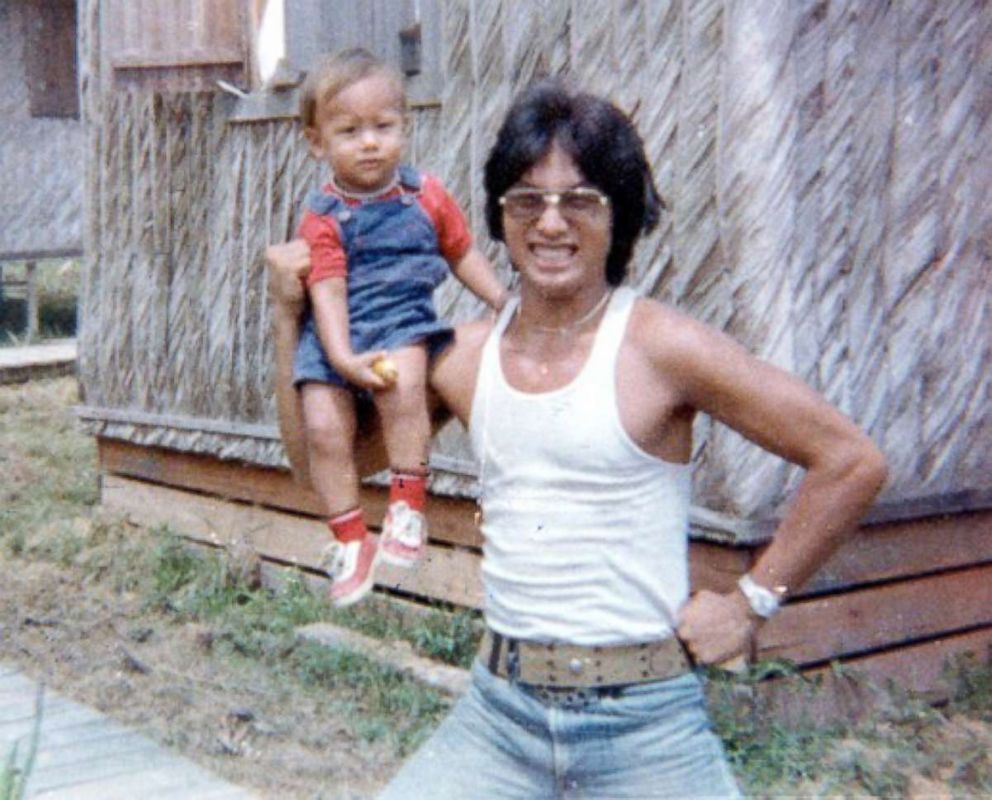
[708,659,992,798]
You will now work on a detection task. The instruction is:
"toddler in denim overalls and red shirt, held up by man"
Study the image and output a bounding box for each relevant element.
[294,49,506,606]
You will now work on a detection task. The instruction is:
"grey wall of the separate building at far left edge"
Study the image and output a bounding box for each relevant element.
[0,2,84,260]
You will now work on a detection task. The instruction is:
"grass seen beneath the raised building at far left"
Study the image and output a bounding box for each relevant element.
[0,259,81,347]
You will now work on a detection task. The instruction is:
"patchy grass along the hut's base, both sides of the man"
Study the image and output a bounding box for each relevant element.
[0,379,992,800]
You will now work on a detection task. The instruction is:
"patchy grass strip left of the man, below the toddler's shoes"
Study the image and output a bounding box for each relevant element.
[0,379,449,754]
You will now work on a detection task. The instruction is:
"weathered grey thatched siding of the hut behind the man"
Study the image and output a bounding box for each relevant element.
[81,0,992,527]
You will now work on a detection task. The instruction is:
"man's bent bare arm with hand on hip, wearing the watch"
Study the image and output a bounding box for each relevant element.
[647,300,886,662]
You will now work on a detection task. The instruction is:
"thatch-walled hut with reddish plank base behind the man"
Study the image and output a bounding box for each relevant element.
[73,0,992,700]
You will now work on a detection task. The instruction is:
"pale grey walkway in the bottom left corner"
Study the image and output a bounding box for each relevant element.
[0,664,259,800]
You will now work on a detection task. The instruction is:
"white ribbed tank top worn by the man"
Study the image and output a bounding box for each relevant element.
[469,287,690,645]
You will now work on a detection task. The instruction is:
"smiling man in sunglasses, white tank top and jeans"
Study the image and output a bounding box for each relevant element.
[269,82,885,800]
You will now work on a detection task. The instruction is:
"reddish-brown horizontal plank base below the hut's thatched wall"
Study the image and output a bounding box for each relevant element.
[99,439,992,700]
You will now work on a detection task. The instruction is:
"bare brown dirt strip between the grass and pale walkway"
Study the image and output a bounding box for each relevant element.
[0,532,406,798]
